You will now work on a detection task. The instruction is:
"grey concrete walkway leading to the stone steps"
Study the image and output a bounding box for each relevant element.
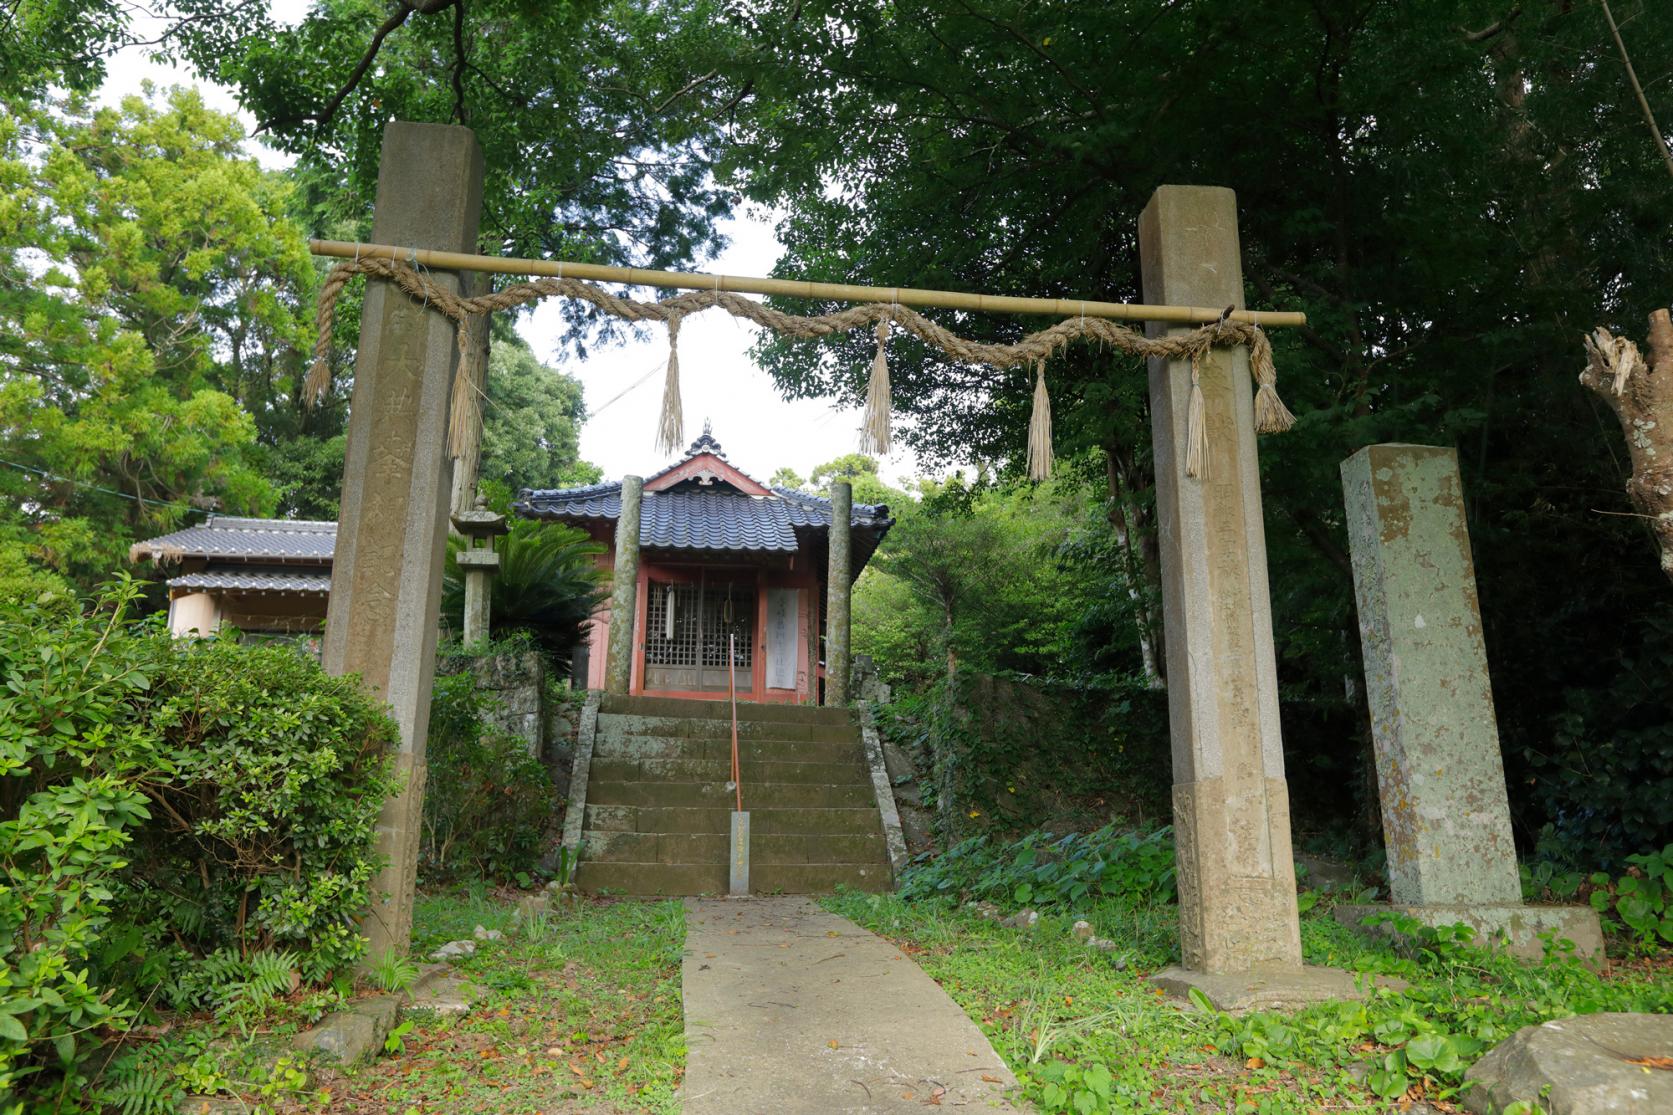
[683,897,1024,1115]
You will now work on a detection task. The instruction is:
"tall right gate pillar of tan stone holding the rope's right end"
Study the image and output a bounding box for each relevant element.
[1139,186,1352,1010]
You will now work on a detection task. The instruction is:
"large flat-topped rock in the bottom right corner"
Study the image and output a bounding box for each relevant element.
[1464,1015,1673,1115]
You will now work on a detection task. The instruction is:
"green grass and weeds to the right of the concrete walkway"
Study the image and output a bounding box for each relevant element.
[825,894,1673,1115]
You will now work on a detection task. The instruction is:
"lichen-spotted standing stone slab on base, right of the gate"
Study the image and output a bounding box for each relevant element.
[1340,445,1601,956]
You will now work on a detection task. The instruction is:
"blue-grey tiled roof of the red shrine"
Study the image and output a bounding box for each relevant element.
[512,484,893,554]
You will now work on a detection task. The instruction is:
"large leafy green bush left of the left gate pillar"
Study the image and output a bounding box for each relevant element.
[0,579,395,1108]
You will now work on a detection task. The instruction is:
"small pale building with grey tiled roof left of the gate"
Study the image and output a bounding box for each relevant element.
[129,516,336,635]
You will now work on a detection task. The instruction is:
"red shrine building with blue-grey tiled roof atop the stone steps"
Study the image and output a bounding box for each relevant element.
[512,424,893,703]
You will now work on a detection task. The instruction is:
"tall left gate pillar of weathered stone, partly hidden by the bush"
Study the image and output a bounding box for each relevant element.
[321,121,482,963]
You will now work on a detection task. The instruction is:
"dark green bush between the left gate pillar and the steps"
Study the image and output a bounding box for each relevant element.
[418,671,557,882]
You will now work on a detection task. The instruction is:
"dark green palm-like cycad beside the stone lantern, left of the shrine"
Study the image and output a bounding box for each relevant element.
[442,519,606,666]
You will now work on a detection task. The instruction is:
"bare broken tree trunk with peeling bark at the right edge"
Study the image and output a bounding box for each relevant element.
[1579,310,1673,579]
